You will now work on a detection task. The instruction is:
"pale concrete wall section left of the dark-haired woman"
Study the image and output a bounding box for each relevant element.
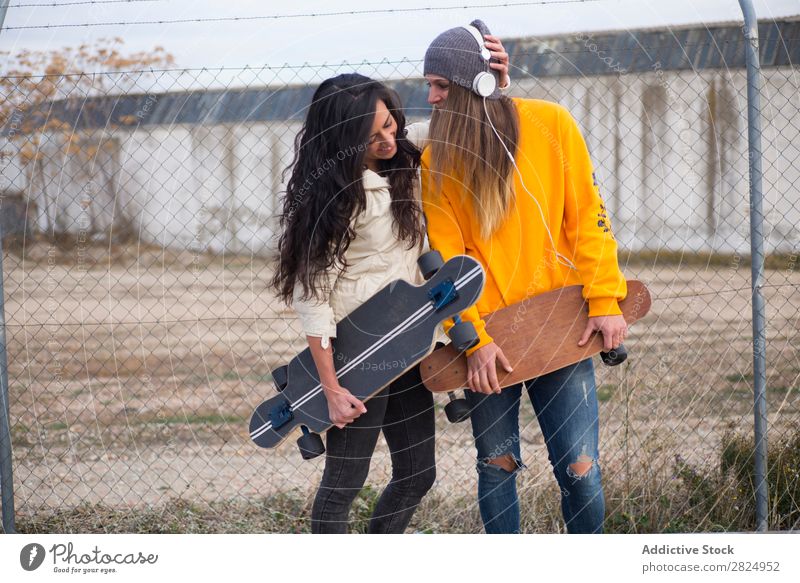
[8,123,300,254]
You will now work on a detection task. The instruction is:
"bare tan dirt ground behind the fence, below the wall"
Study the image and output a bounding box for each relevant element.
[4,244,800,513]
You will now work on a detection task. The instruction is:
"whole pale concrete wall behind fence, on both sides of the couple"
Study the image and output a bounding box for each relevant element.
[14,69,800,254]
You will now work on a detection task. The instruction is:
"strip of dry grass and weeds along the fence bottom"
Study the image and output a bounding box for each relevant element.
[18,428,800,533]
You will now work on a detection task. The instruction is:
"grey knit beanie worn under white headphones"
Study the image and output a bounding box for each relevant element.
[423,20,501,99]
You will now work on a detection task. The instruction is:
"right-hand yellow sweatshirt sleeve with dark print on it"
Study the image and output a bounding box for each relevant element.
[559,108,627,317]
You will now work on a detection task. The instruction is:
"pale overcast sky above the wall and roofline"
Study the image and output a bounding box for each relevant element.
[0,0,800,85]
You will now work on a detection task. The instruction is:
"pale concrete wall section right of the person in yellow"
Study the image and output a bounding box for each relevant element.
[514,69,800,253]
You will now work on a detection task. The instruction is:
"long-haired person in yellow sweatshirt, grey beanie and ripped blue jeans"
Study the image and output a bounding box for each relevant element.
[421,20,627,533]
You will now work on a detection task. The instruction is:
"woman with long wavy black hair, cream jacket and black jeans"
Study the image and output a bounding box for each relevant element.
[273,74,436,533]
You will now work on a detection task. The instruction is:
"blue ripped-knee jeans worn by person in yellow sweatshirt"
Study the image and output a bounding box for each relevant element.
[466,359,605,534]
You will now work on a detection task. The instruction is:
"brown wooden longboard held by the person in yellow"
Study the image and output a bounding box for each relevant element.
[420,280,651,392]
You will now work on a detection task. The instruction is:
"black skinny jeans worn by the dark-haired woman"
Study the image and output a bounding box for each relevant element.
[311,366,436,533]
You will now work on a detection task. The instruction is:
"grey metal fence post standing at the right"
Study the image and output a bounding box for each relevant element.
[739,0,768,532]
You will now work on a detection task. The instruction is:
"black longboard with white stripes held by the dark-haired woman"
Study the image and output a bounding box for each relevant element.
[250,252,485,458]
